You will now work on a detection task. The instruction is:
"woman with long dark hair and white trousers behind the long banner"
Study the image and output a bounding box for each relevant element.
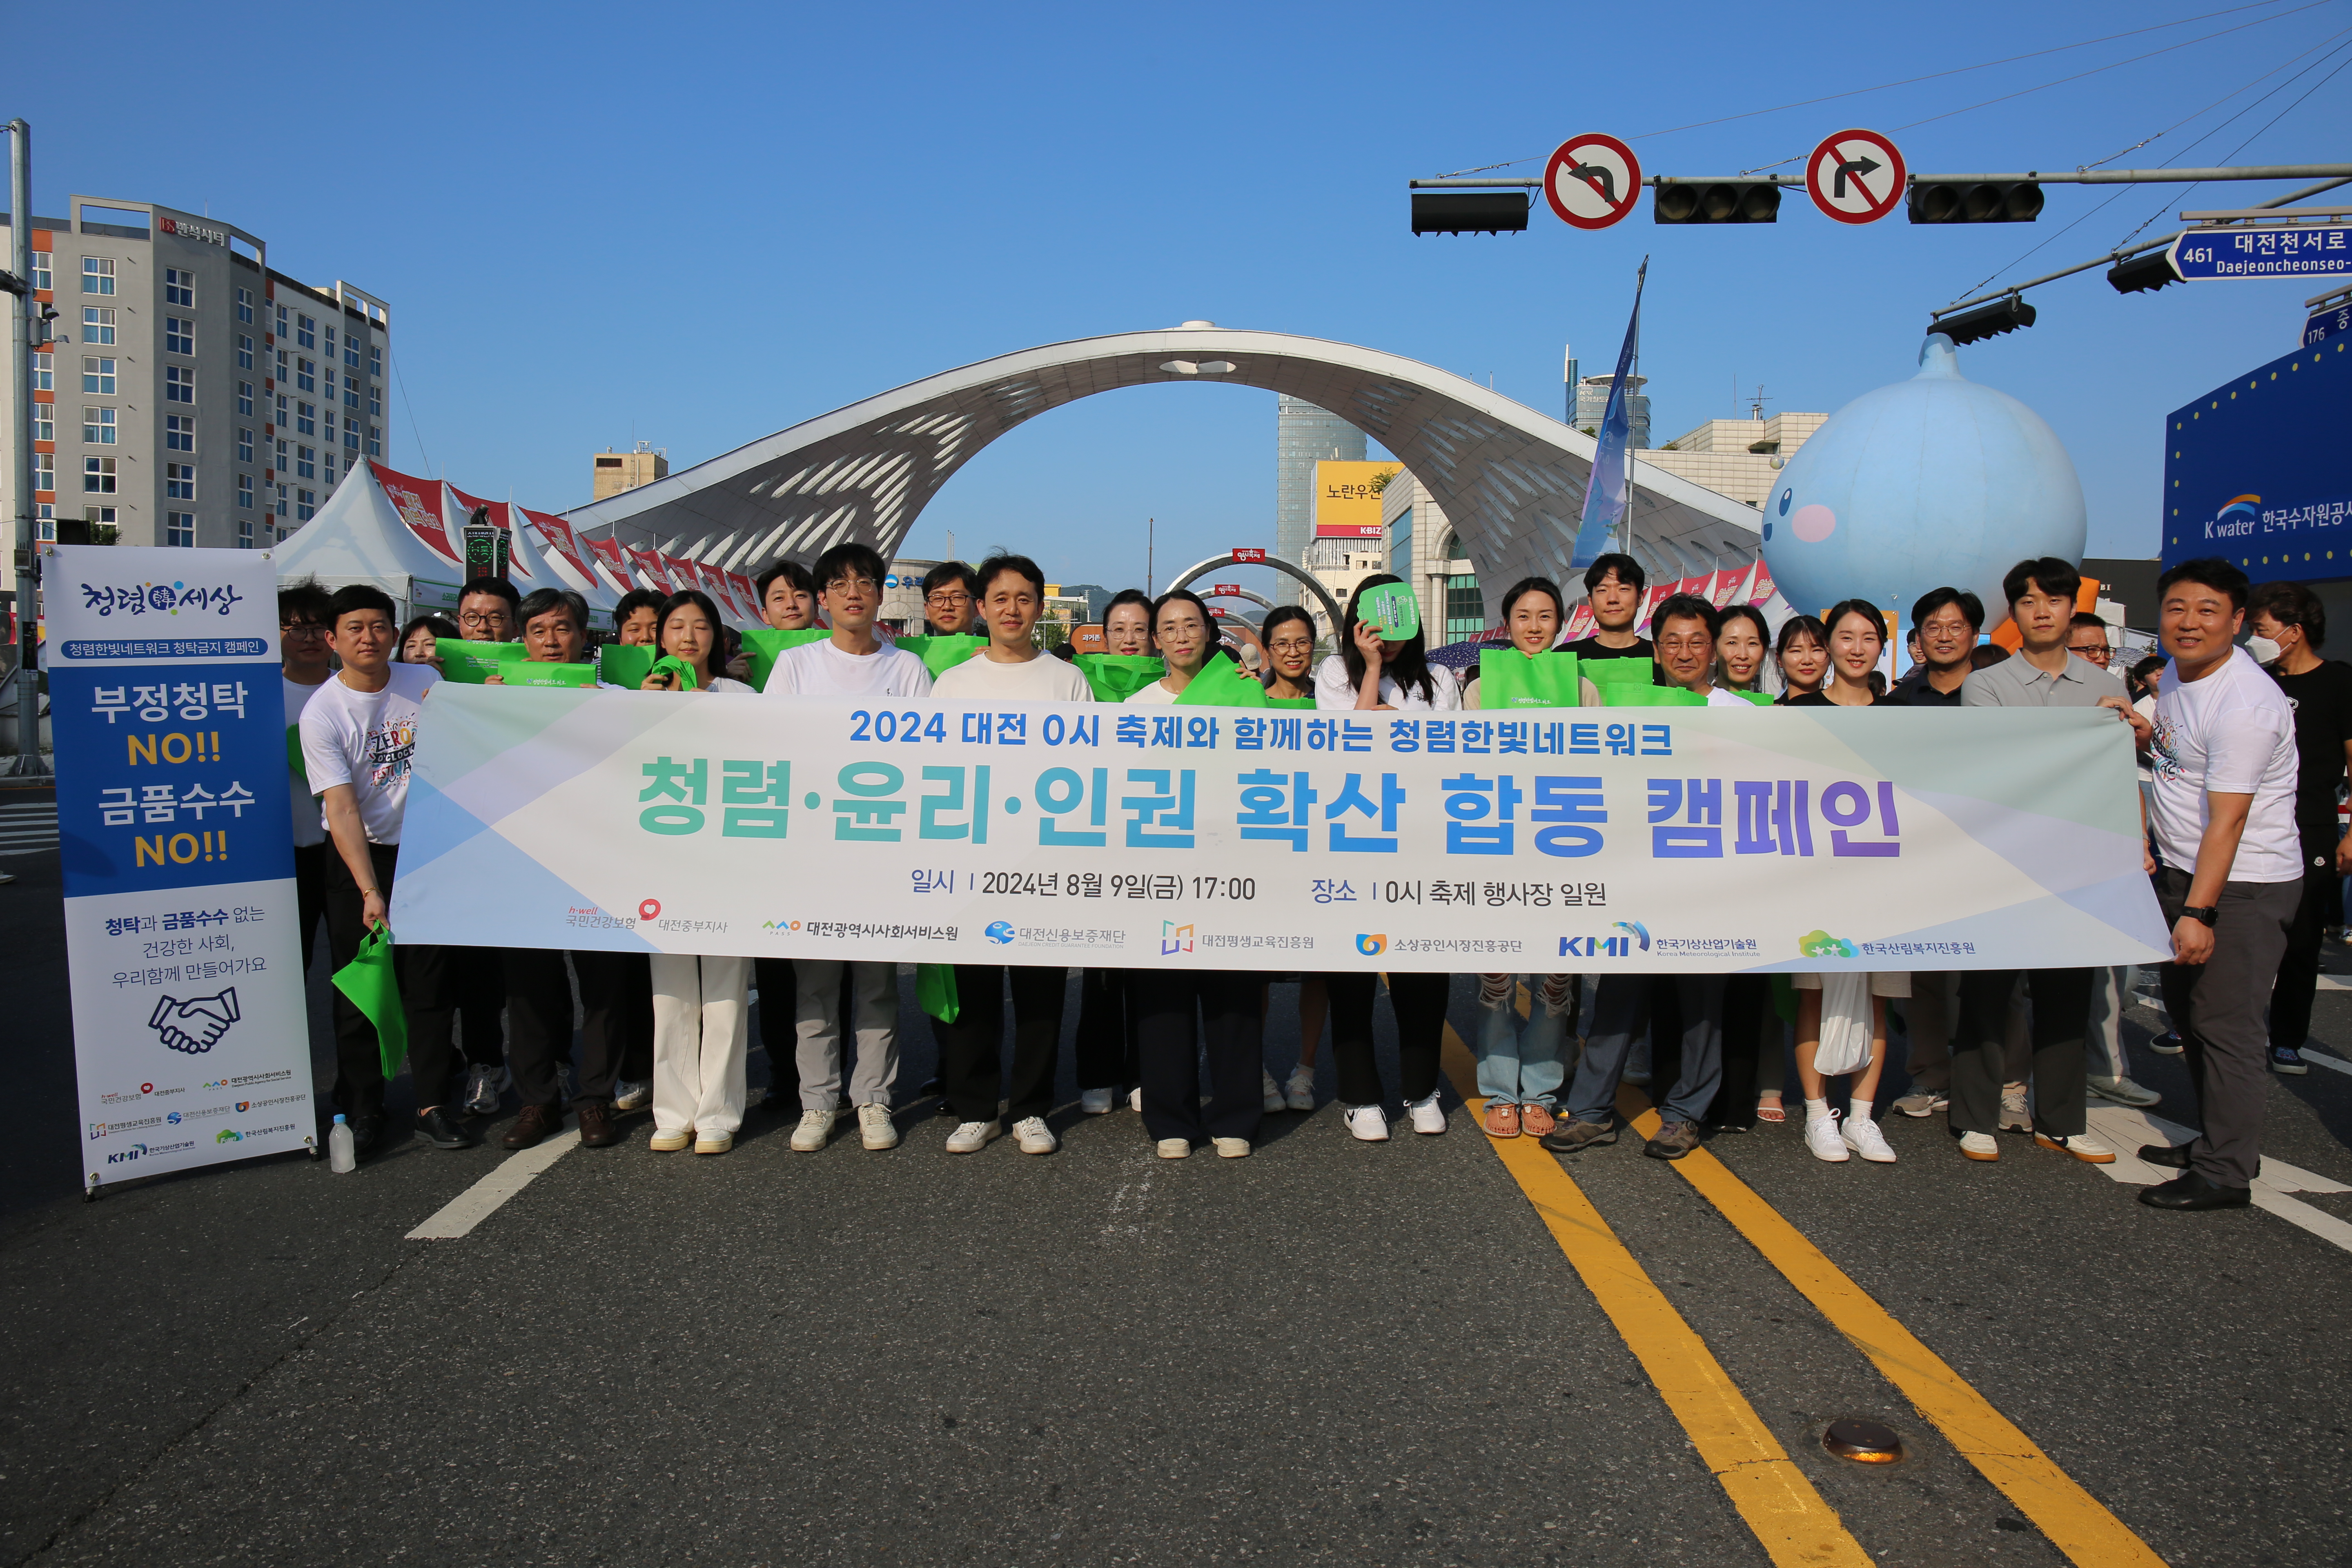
[644,588,750,1154]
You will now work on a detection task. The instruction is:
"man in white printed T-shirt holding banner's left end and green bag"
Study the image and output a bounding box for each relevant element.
[301,583,475,1154]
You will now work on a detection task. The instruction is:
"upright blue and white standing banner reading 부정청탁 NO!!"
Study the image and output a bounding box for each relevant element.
[40,546,318,1187]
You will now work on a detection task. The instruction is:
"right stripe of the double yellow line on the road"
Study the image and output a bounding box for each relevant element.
[1618,1091,2164,1568]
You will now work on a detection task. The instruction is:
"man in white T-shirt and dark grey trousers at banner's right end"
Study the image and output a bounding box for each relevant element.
[2140,557,2303,1208]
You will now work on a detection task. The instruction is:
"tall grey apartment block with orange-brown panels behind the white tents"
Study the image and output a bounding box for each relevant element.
[0,195,390,597]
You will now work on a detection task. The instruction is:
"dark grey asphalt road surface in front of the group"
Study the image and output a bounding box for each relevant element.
[0,799,2352,1566]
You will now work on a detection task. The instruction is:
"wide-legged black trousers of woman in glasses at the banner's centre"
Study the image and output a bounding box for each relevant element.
[1127,969,1265,1143]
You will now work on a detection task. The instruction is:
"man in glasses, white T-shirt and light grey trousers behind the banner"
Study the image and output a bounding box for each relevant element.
[762,546,931,1154]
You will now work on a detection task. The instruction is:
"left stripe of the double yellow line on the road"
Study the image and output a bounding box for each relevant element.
[1446,1025,1870,1568]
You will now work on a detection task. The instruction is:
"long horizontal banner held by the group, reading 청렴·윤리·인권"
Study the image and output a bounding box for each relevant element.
[393,684,2164,973]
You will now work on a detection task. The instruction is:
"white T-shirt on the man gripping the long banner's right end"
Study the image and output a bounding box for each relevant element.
[2147,649,2303,882]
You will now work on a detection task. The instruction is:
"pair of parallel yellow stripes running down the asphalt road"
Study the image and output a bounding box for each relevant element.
[1444,1025,2164,1568]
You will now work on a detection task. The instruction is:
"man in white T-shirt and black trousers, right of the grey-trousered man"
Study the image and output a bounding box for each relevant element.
[931,555,1094,1154]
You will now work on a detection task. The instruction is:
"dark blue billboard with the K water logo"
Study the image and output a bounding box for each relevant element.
[2164,339,2352,583]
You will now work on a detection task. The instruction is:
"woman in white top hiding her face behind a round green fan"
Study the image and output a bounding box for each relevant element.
[1315,571,1463,1143]
